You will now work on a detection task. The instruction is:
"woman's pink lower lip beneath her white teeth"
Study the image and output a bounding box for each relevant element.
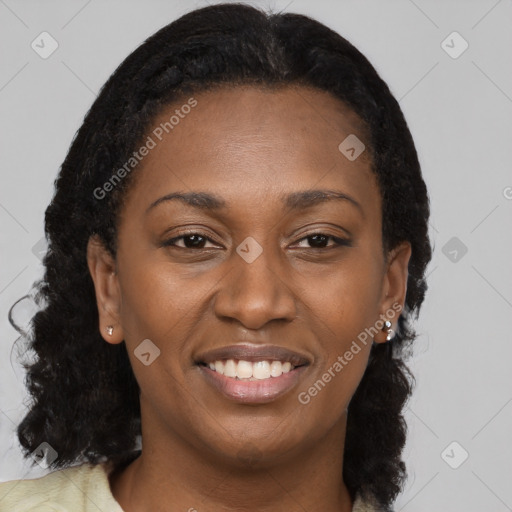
[199,365,307,404]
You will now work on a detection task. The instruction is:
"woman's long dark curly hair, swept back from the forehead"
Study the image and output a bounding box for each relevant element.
[11,4,432,507]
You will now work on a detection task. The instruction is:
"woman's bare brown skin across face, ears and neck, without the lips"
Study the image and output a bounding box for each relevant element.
[87,86,411,512]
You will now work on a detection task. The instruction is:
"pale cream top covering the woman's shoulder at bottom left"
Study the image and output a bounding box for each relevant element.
[0,462,123,512]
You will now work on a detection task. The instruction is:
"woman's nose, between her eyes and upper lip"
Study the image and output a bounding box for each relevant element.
[215,245,296,329]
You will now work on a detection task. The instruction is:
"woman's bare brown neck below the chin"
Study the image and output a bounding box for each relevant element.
[111,417,352,512]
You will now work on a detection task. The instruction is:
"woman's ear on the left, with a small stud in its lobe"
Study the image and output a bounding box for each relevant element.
[87,235,124,344]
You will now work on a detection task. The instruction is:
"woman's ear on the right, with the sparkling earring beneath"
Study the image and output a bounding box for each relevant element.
[374,241,412,343]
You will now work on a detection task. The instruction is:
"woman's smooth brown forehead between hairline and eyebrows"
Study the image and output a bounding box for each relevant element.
[120,86,375,216]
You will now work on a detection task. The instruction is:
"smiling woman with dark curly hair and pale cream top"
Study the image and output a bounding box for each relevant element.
[0,4,431,512]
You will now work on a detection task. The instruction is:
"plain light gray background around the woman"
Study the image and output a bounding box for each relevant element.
[0,0,512,512]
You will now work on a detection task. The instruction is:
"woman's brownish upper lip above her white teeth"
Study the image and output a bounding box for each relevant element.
[195,343,311,366]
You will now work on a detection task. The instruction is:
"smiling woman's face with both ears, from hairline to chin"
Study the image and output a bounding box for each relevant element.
[88,87,410,462]
